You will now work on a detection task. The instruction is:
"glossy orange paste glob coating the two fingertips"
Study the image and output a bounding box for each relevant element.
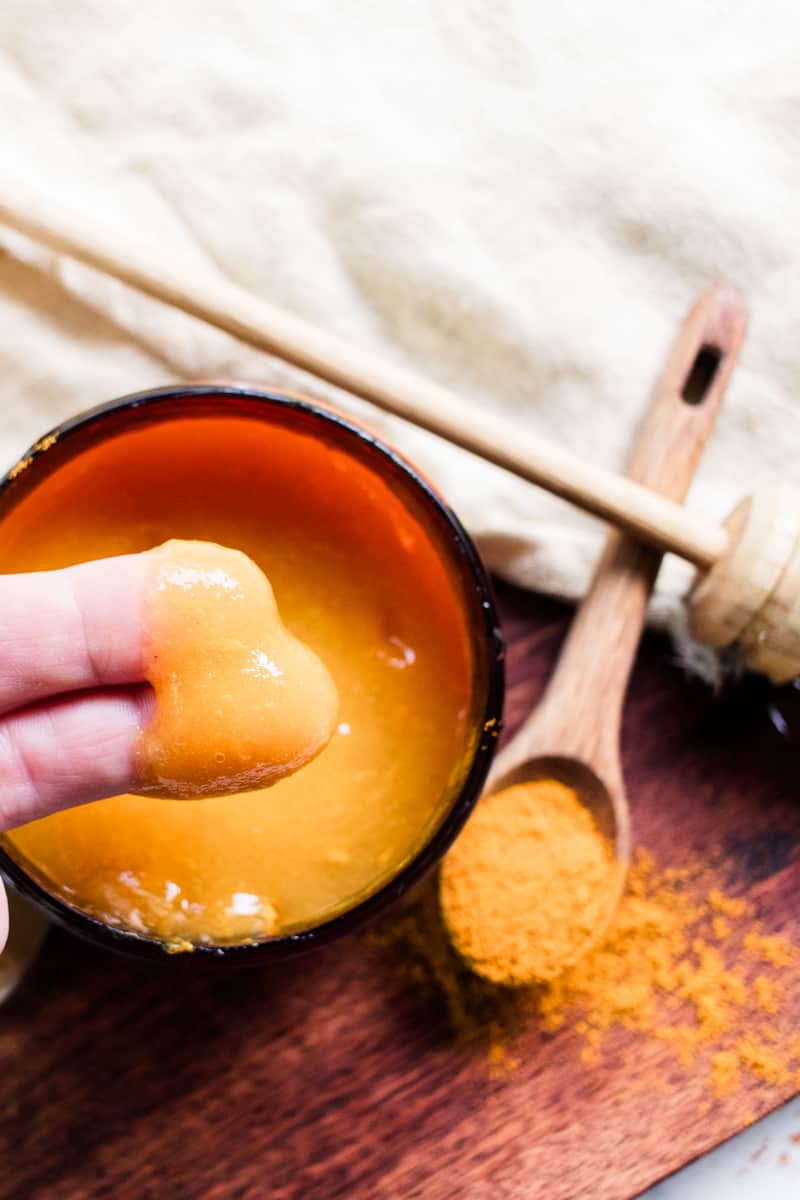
[136,540,338,799]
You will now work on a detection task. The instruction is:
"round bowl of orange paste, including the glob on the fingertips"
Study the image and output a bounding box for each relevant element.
[0,389,501,958]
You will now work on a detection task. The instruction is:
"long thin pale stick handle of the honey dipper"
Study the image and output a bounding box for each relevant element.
[0,176,746,568]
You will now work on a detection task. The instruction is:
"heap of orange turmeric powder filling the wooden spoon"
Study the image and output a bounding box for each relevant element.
[440,779,616,986]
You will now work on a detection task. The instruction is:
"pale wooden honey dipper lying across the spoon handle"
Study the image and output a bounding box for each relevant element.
[0,180,800,683]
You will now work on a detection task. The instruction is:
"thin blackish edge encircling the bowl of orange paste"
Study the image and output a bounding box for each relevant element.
[0,383,505,965]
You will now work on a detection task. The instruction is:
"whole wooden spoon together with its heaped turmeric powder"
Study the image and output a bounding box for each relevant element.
[440,290,744,985]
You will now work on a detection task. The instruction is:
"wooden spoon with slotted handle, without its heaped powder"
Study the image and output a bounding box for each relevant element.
[441,292,744,984]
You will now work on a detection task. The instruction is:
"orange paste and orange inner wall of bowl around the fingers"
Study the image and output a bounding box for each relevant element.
[0,416,476,948]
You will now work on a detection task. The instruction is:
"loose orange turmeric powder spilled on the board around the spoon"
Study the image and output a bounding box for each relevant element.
[372,851,800,1099]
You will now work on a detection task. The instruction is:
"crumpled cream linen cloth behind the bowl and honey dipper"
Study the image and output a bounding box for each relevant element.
[0,0,800,984]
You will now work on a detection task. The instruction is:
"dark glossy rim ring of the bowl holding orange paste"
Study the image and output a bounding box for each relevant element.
[0,386,504,964]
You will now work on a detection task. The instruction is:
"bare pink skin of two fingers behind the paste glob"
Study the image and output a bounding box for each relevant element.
[0,554,155,950]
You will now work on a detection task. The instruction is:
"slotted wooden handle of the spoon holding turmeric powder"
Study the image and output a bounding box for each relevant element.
[510,289,745,778]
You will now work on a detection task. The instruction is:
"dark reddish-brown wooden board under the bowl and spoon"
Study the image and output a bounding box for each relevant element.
[0,578,800,1200]
